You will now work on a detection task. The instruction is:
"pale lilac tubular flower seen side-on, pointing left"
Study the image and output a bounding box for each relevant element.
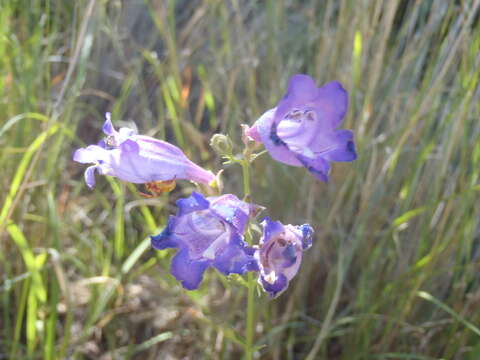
[73,113,215,188]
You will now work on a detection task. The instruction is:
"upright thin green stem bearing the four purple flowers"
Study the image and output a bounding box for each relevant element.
[242,159,255,360]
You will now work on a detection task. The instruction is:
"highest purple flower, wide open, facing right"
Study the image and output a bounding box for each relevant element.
[246,74,357,182]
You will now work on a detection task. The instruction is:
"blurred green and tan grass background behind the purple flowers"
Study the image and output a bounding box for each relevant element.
[0,0,480,360]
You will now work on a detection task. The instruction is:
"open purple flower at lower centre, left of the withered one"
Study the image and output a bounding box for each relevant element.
[152,192,259,290]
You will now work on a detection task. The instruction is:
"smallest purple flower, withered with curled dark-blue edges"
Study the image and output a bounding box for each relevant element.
[255,218,313,297]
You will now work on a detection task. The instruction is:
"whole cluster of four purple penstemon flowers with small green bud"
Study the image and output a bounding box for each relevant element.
[73,74,357,297]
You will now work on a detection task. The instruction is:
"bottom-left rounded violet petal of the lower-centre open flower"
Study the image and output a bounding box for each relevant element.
[171,249,208,290]
